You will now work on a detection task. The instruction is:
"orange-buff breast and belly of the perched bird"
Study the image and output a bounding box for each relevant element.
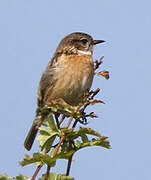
[47,55,94,106]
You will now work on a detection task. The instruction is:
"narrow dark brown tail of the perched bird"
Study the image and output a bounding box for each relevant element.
[24,116,42,151]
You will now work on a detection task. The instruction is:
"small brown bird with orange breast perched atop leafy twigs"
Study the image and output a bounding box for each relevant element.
[24,32,105,151]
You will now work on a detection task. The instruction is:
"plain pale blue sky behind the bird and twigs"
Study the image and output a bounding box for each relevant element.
[0,0,151,180]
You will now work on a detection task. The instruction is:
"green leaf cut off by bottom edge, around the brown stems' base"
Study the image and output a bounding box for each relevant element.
[39,173,74,180]
